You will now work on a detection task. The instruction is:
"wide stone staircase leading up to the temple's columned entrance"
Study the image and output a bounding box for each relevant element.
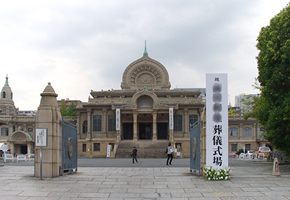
[115,140,169,158]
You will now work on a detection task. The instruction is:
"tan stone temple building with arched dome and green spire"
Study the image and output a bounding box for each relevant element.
[76,47,205,157]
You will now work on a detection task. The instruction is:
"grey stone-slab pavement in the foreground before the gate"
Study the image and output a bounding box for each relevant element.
[0,165,290,200]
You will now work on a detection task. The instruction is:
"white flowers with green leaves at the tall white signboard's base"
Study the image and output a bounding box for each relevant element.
[203,166,231,181]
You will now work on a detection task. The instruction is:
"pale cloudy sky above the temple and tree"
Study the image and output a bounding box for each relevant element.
[0,0,289,110]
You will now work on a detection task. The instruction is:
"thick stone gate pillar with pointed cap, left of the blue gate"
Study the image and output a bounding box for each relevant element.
[34,83,62,178]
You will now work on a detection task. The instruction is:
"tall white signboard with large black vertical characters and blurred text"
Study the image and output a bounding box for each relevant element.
[206,74,228,169]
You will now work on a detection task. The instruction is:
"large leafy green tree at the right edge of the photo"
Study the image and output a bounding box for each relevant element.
[253,4,290,156]
